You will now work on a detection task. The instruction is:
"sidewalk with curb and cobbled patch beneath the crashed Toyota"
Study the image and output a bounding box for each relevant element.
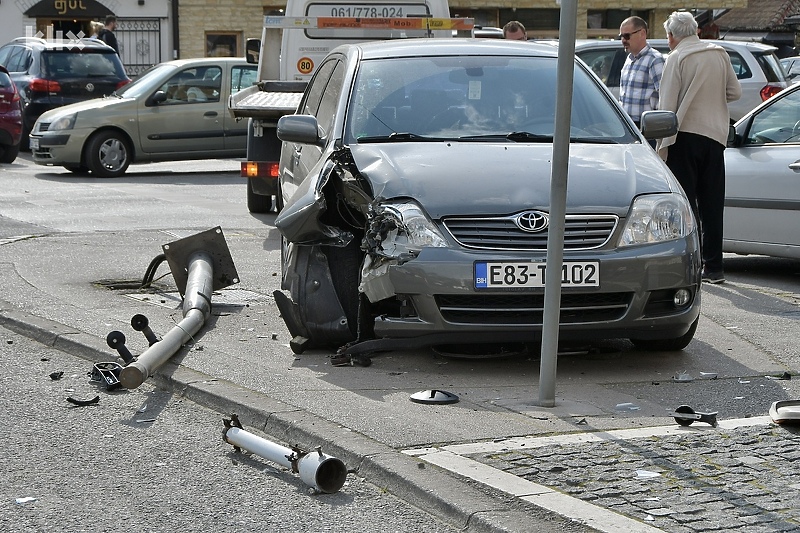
[0,228,800,532]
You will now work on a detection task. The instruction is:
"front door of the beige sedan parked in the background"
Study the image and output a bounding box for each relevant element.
[138,65,227,154]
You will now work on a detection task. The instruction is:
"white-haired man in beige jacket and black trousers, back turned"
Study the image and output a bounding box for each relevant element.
[656,11,742,283]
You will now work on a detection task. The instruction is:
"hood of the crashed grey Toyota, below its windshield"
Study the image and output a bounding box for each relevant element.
[350,142,679,219]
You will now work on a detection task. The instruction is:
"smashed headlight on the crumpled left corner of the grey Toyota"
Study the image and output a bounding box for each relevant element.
[369,201,447,258]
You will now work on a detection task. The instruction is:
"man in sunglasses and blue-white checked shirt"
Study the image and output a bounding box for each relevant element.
[619,17,664,133]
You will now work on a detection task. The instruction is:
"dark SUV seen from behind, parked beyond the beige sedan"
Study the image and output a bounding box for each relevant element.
[0,37,131,150]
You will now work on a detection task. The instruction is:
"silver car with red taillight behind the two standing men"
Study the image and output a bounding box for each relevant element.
[575,39,789,122]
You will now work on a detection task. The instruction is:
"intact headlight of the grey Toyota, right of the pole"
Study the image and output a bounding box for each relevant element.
[619,194,695,246]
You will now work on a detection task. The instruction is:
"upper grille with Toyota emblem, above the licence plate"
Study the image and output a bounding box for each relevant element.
[444,215,619,251]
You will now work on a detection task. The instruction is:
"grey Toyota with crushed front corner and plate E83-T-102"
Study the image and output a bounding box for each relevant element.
[275,39,701,353]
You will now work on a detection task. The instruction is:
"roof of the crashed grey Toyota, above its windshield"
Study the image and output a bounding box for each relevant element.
[337,38,558,59]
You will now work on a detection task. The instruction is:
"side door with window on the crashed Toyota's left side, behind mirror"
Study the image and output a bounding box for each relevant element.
[281,56,345,198]
